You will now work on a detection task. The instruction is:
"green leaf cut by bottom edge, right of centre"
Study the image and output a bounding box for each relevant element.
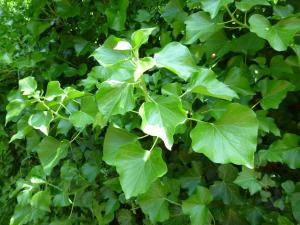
[182,187,213,225]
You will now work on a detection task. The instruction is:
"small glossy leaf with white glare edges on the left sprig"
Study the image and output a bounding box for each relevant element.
[28,111,53,135]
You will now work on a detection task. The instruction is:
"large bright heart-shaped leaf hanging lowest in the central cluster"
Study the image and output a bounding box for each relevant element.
[116,142,167,199]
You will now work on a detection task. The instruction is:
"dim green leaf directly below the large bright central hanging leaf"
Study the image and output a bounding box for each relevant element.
[138,181,169,223]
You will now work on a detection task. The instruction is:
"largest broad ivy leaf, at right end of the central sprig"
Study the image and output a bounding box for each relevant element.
[190,103,258,168]
